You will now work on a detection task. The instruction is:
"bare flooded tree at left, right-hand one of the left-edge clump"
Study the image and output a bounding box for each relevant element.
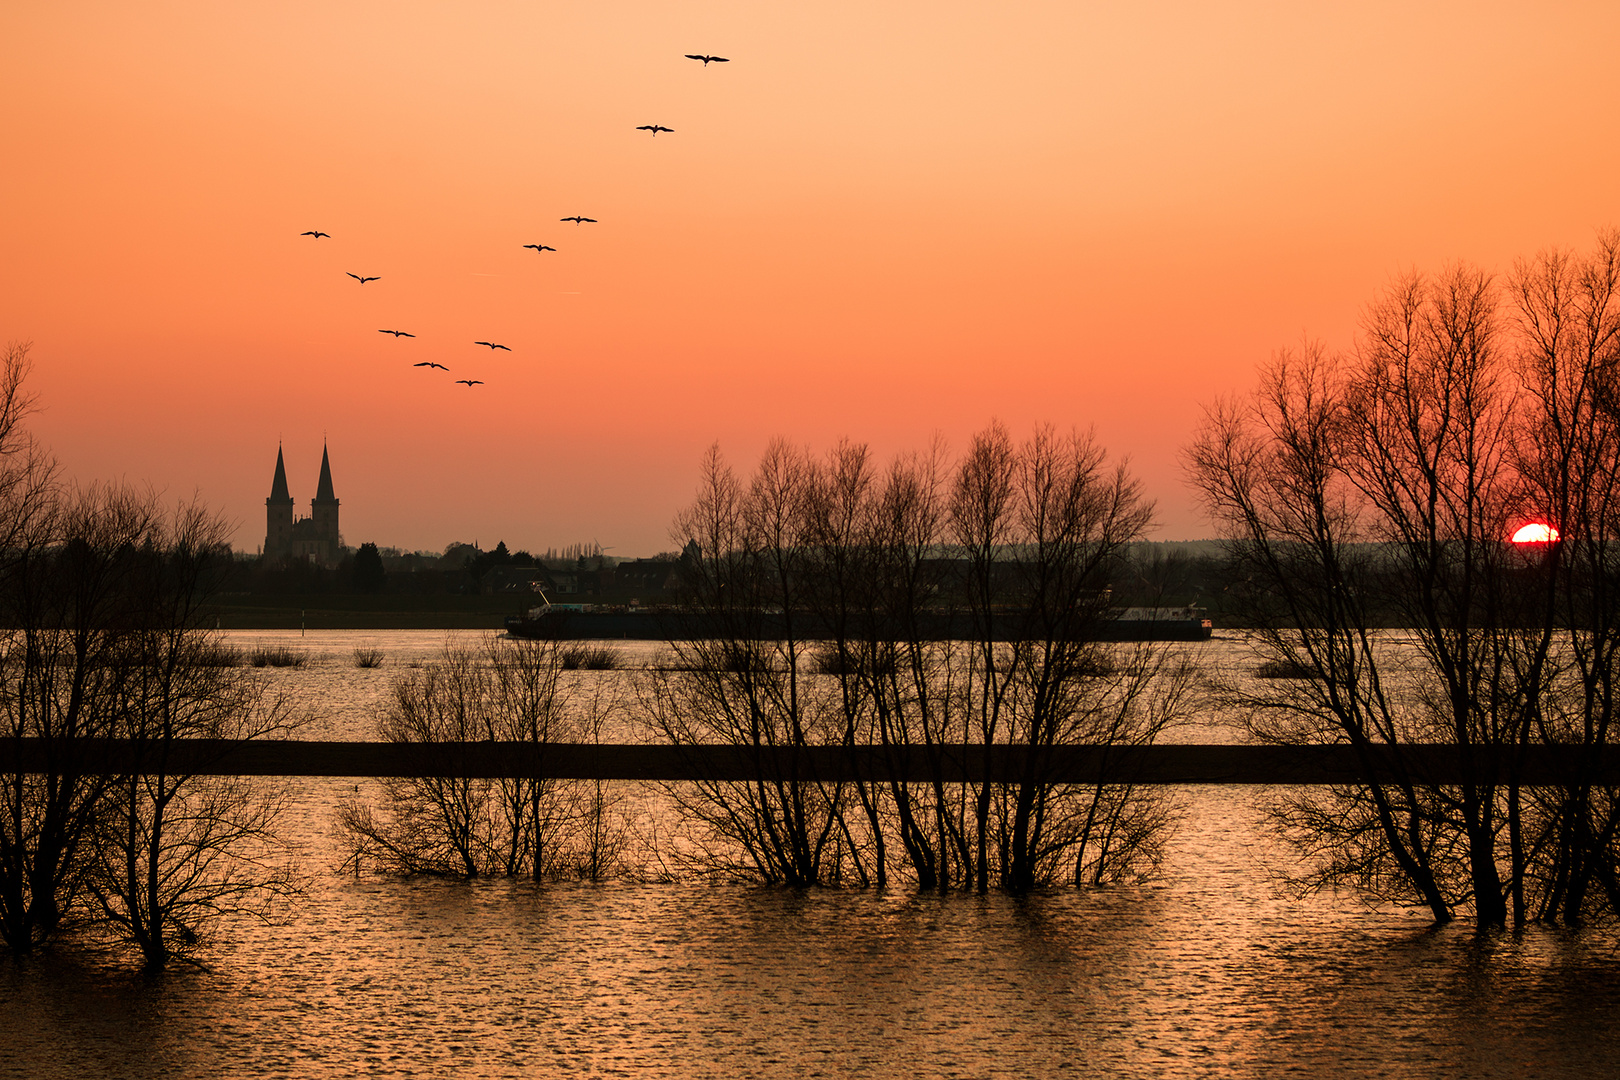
[80,489,296,970]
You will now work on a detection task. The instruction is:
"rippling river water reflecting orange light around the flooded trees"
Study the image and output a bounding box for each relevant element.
[0,631,1620,1080]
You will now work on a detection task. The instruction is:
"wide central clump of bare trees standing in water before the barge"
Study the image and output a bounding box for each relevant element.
[648,427,1186,891]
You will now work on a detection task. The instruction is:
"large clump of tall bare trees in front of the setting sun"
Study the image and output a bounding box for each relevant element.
[1189,238,1620,925]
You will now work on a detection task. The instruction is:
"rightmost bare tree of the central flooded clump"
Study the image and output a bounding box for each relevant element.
[953,426,1187,892]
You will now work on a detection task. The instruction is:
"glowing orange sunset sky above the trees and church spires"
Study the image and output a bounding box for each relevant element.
[0,0,1620,555]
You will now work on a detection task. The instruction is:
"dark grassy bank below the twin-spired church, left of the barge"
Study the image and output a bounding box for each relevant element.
[209,593,517,630]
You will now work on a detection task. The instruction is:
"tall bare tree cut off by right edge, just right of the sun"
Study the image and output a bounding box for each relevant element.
[1508,232,1620,923]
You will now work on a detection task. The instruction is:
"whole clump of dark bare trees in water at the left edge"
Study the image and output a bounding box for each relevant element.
[0,347,298,968]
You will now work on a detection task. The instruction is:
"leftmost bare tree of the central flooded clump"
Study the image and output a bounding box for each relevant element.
[642,442,872,886]
